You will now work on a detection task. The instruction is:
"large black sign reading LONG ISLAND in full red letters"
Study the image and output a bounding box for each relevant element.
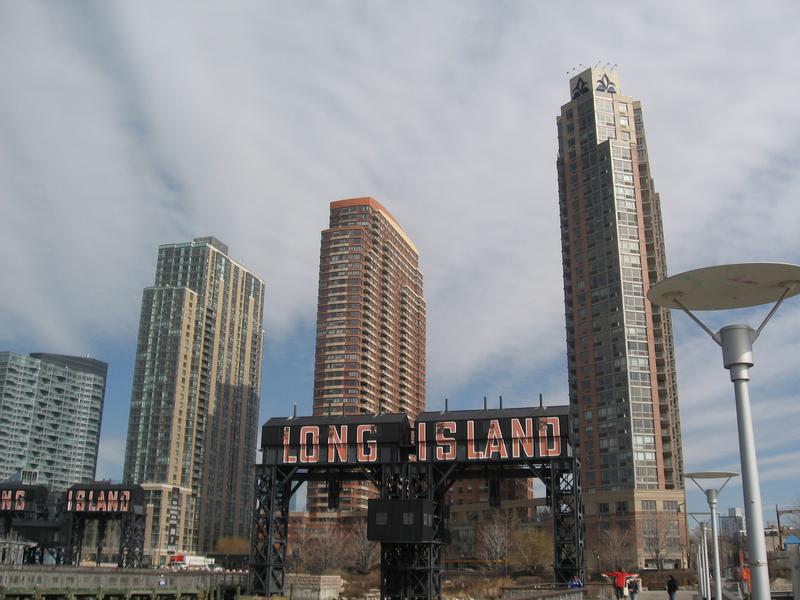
[262,407,571,466]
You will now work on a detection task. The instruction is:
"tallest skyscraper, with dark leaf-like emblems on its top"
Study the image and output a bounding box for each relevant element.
[557,69,685,567]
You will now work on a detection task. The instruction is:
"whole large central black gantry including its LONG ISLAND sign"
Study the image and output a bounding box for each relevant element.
[249,406,584,600]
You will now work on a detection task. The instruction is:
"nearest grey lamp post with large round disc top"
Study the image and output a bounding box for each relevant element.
[647,263,800,600]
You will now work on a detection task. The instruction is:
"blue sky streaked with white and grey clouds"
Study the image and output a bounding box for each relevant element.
[0,0,800,521]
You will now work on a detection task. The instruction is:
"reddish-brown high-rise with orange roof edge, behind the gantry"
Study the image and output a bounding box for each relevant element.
[308,198,425,512]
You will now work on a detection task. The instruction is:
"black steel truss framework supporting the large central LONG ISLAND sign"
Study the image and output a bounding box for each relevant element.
[249,458,584,600]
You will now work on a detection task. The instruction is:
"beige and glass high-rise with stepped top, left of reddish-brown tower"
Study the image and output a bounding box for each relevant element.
[124,237,264,564]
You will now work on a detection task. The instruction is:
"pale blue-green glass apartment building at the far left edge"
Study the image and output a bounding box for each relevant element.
[0,352,108,491]
